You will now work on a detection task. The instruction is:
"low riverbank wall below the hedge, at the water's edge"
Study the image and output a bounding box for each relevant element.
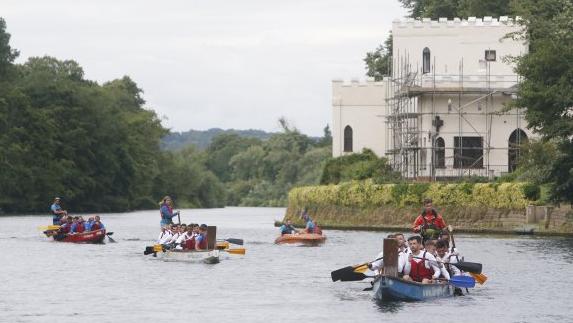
[276,205,573,236]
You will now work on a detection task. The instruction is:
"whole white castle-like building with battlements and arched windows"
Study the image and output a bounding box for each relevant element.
[332,17,531,179]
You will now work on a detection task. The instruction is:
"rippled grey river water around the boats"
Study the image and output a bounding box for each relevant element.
[0,208,573,323]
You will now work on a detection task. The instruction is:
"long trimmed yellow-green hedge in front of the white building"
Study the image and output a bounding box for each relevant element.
[289,180,539,209]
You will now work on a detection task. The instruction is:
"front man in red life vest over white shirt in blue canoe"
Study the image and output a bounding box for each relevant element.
[402,236,441,284]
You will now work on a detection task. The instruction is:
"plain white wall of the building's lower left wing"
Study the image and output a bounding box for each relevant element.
[332,80,387,157]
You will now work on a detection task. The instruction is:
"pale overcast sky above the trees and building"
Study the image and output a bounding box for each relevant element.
[4,0,406,136]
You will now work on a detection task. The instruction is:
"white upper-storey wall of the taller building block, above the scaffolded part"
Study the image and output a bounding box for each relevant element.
[392,17,527,82]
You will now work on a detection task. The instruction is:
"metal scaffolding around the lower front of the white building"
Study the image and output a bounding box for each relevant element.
[386,54,527,181]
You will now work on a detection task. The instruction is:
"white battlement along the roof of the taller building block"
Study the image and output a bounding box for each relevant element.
[392,16,520,28]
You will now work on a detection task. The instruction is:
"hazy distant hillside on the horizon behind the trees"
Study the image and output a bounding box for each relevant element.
[161,128,273,150]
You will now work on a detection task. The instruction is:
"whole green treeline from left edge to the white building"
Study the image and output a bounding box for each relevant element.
[0,18,338,213]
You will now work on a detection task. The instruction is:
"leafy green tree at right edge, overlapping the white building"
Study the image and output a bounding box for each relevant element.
[512,0,573,202]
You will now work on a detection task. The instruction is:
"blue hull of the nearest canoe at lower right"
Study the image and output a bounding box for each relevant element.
[373,276,454,301]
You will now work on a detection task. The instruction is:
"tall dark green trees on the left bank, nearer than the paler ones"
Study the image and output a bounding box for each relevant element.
[0,19,226,212]
